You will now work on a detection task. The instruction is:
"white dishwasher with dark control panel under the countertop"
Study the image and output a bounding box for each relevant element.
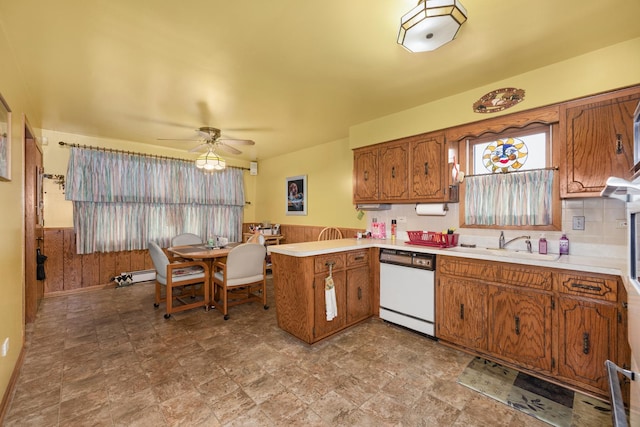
[380,249,436,337]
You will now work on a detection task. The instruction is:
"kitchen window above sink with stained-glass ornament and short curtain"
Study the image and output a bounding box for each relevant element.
[461,124,561,229]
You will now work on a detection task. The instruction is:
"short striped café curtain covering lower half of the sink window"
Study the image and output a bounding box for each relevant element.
[464,170,555,226]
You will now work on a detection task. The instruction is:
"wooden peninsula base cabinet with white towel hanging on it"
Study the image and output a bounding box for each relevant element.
[271,249,373,344]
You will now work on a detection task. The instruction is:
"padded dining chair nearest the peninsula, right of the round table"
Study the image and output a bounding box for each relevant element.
[212,243,269,320]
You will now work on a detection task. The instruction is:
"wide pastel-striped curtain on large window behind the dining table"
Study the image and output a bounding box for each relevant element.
[65,147,244,254]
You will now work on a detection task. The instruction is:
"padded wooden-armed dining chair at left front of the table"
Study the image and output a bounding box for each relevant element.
[149,242,209,319]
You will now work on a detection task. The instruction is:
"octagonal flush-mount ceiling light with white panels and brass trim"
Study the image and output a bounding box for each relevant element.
[398,0,467,52]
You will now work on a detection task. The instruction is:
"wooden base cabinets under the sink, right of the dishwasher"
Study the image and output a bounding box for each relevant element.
[436,256,629,397]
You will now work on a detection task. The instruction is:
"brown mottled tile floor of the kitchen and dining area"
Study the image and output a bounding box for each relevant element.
[4,283,580,427]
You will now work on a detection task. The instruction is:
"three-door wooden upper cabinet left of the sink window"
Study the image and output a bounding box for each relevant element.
[353,133,452,203]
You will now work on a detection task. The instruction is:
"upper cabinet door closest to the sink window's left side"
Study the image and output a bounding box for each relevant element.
[410,135,448,202]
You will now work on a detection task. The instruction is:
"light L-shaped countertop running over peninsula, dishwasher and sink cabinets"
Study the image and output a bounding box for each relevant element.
[268,239,627,277]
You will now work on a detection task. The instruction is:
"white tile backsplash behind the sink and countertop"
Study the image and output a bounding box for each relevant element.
[367,198,628,258]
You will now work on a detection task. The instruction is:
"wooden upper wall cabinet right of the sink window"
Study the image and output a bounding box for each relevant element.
[560,87,640,198]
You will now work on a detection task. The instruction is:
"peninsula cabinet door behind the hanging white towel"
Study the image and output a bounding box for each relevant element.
[313,271,347,340]
